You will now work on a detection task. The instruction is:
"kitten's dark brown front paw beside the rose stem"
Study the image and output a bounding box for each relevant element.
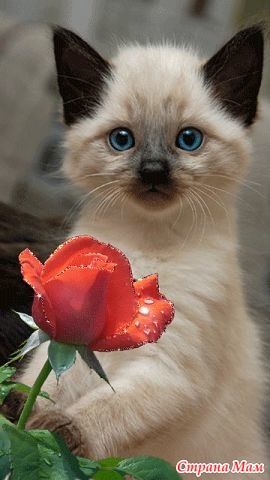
[26,409,86,457]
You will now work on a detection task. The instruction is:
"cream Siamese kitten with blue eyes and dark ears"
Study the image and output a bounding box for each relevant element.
[18,26,267,479]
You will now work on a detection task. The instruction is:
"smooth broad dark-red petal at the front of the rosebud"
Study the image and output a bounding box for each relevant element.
[45,264,113,345]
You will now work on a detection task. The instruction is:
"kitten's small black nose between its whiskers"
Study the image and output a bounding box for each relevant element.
[139,160,170,185]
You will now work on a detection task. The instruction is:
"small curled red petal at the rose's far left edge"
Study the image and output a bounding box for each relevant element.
[19,248,44,295]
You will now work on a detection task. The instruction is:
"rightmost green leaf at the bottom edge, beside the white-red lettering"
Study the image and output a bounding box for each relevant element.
[115,457,180,480]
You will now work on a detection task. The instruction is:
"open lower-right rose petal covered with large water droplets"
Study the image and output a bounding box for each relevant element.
[92,297,174,352]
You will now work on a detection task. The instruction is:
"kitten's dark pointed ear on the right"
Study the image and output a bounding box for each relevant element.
[203,25,263,126]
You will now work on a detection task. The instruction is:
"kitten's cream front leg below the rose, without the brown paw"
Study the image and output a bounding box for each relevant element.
[60,348,200,459]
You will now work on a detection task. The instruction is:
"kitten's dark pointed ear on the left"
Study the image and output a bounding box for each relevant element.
[53,27,110,125]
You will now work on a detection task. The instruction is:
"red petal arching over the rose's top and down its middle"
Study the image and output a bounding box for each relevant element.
[42,236,138,336]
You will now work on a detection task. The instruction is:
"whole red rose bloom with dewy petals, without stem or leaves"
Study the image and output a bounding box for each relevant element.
[19,236,174,351]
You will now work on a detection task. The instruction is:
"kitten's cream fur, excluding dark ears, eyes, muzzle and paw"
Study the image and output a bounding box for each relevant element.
[22,46,268,479]
